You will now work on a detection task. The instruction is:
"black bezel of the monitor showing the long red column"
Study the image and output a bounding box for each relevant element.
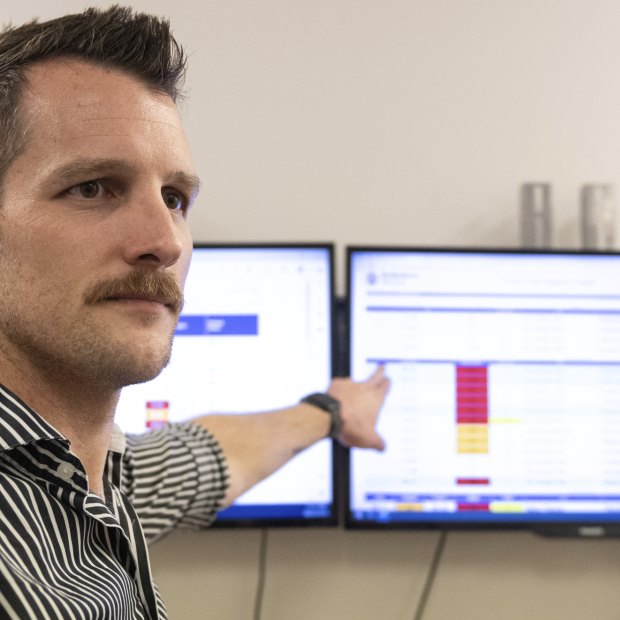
[339,244,620,538]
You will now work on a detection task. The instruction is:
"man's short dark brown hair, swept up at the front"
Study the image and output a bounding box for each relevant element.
[0,6,187,191]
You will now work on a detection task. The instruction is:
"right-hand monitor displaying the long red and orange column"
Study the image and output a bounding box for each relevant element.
[347,247,620,535]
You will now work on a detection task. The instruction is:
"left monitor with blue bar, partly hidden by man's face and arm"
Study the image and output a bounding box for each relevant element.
[116,244,335,525]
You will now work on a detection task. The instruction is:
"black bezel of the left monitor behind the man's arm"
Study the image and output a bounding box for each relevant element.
[186,241,341,529]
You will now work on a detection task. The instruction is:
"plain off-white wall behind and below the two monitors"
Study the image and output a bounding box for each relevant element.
[6,0,620,620]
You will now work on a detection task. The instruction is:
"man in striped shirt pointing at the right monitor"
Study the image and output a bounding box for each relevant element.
[0,7,388,620]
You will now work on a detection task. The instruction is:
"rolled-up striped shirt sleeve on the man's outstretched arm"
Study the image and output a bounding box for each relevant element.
[121,422,229,543]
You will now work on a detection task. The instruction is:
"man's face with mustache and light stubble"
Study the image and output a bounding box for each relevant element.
[0,60,197,389]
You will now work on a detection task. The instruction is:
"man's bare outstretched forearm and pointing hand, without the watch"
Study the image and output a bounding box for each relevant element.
[192,367,389,506]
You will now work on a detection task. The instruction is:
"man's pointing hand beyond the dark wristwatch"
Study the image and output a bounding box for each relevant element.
[327,366,390,450]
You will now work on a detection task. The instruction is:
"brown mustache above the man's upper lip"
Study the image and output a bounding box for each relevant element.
[84,271,184,314]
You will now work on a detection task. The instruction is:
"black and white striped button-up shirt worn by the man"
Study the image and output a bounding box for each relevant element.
[0,386,228,620]
